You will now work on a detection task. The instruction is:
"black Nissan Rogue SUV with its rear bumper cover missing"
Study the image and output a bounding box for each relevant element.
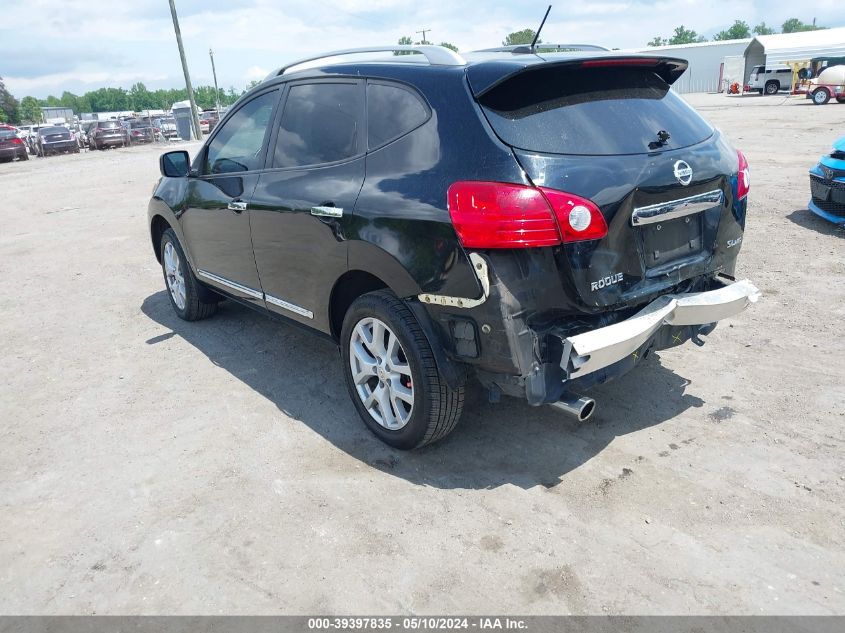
[149,46,759,449]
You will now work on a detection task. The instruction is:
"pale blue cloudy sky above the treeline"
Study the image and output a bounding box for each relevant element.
[0,0,845,99]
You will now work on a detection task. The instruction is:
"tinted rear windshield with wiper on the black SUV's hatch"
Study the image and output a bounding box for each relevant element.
[480,68,713,156]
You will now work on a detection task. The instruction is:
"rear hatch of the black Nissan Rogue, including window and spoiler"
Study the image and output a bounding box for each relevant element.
[469,58,744,308]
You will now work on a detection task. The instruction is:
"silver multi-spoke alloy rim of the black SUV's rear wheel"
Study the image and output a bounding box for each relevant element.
[349,317,414,431]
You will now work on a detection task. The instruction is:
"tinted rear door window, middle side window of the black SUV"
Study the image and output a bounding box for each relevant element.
[273,82,364,167]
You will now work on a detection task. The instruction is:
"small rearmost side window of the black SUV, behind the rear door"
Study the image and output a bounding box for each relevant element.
[367,82,428,149]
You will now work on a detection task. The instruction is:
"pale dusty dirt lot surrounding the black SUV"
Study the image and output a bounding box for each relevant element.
[0,95,845,614]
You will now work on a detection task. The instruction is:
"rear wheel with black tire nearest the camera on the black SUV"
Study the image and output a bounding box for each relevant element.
[340,290,464,450]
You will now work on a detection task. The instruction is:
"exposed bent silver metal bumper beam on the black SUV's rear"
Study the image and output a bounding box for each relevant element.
[560,279,760,380]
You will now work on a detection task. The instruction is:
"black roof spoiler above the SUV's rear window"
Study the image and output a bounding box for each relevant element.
[467,54,688,97]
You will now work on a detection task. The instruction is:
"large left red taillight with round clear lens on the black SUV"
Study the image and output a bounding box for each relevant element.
[447,181,607,248]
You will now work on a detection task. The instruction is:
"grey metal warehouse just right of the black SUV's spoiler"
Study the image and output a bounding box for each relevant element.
[630,38,752,93]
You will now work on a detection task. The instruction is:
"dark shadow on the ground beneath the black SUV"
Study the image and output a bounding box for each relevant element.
[141,291,704,489]
